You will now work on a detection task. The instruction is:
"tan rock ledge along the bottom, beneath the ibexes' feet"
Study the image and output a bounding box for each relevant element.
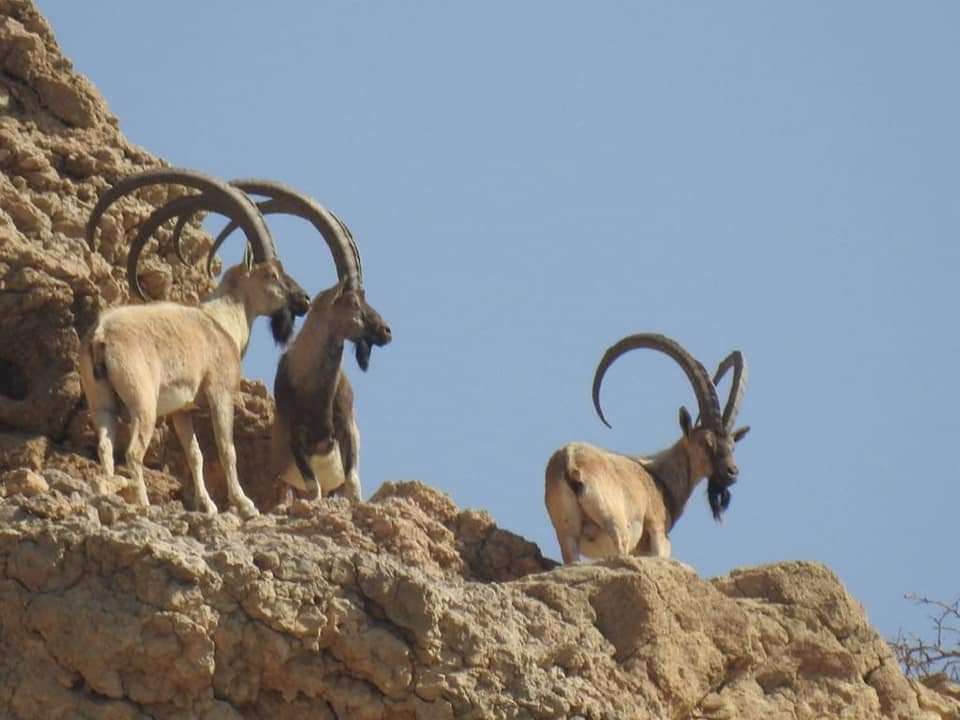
[0,478,960,720]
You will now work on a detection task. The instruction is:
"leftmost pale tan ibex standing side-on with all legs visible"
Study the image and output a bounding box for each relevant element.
[80,168,305,517]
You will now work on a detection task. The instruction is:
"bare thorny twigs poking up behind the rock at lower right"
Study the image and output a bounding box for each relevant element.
[890,593,960,682]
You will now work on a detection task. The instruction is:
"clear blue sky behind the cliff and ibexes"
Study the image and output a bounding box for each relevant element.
[40,0,960,635]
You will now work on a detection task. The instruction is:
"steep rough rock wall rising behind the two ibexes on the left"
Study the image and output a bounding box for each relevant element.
[0,0,273,508]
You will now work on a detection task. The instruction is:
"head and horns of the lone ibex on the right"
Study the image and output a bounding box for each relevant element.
[593,333,750,521]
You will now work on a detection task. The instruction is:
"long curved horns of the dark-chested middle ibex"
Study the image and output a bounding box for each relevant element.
[207,179,363,286]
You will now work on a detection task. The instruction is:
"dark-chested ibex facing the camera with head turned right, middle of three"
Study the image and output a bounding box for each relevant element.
[195,180,392,500]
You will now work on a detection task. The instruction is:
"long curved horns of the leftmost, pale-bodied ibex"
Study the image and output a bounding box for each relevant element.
[86,168,277,300]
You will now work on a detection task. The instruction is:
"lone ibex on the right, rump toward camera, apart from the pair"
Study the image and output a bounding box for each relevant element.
[546,333,750,563]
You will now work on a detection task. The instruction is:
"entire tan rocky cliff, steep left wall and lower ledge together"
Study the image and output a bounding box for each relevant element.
[0,0,960,720]
